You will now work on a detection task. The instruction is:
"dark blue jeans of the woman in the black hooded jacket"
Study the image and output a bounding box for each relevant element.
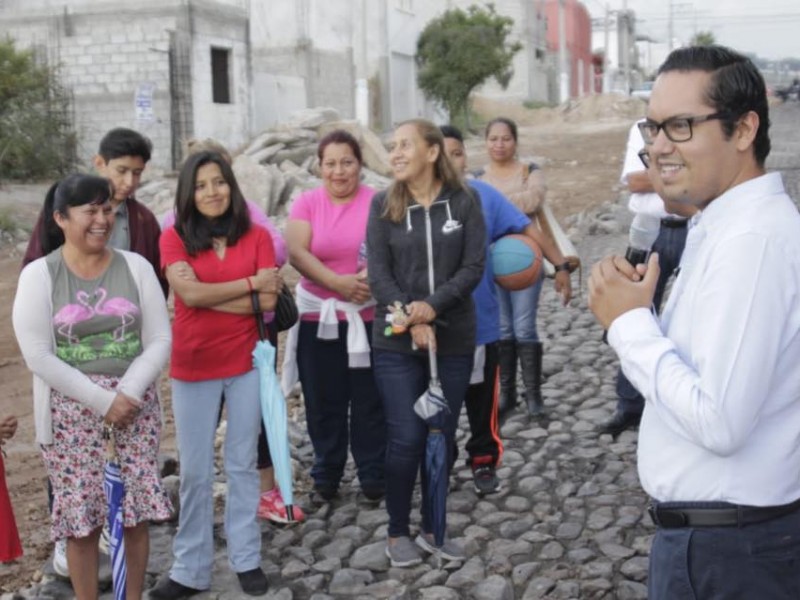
[374,349,473,537]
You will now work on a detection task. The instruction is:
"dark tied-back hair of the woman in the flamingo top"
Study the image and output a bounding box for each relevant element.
[40,174,111,256]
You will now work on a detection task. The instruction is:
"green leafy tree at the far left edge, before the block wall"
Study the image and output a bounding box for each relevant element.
[0,39,75,179]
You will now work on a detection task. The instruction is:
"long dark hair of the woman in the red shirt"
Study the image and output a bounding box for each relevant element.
[175,152,250,256]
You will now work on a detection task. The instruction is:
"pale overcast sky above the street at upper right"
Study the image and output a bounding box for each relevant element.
[582,0,800,59]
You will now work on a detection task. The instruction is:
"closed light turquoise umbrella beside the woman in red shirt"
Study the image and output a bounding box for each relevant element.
[251,292,294,521]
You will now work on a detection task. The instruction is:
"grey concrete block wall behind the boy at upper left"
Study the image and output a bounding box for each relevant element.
[2,9,174,168]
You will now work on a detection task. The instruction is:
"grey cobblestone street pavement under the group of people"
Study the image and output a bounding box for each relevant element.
[9,103,800,600]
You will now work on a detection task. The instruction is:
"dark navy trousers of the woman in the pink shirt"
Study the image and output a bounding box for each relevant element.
[297,321,386,487]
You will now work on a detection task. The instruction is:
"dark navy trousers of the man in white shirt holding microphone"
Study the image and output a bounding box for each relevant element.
[647,504,800,600]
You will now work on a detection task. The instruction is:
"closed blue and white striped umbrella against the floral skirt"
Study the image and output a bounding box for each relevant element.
[103,427,128,600]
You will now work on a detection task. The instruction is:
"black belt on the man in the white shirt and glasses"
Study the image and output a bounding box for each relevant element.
[647,499,800,529]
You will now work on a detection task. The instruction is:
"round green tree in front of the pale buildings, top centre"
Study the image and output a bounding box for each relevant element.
[416,4,522,127]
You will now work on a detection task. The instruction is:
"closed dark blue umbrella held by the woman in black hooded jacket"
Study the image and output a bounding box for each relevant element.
[414,347,450,548]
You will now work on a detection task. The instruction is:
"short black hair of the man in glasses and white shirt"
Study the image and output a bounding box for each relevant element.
[658,46,771,167]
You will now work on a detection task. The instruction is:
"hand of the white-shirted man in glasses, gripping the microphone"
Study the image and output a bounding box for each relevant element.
[589,253,660,329]
